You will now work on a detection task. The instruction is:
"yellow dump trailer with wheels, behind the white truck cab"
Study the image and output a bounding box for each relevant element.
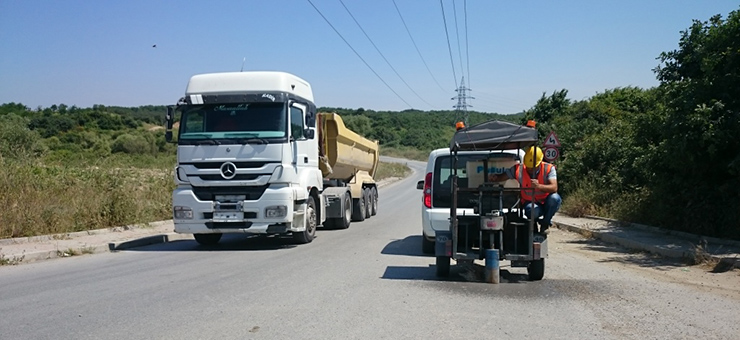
[318,113,379,227]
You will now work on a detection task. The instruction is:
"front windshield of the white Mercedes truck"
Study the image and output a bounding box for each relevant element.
[178,103,288,144]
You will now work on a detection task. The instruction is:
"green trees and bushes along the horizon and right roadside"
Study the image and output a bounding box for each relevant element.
[0,7,740,239]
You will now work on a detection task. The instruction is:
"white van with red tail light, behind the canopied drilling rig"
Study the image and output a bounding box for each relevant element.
[416,148,524,254]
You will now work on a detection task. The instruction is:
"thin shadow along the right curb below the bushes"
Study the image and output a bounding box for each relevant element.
[566,239,687,270]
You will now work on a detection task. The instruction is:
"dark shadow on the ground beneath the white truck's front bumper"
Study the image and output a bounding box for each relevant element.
[120,234,296,252]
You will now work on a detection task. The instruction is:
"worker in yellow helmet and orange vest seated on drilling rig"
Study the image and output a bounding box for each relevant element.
[488,146,562,234]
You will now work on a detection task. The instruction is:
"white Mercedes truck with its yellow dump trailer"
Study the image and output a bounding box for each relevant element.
[166,72,378,244]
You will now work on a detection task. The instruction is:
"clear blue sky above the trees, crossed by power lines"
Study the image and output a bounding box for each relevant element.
[0,0,740,113]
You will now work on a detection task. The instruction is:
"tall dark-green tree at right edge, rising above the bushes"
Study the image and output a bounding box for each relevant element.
[655,11,740,237]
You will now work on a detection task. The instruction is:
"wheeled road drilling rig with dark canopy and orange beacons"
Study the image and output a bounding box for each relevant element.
[435,120,547,283]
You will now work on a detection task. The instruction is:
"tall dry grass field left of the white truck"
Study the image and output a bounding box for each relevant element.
[0,160,174,238]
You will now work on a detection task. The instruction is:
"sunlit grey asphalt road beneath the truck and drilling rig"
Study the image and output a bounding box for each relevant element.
[0,158,740,339]
